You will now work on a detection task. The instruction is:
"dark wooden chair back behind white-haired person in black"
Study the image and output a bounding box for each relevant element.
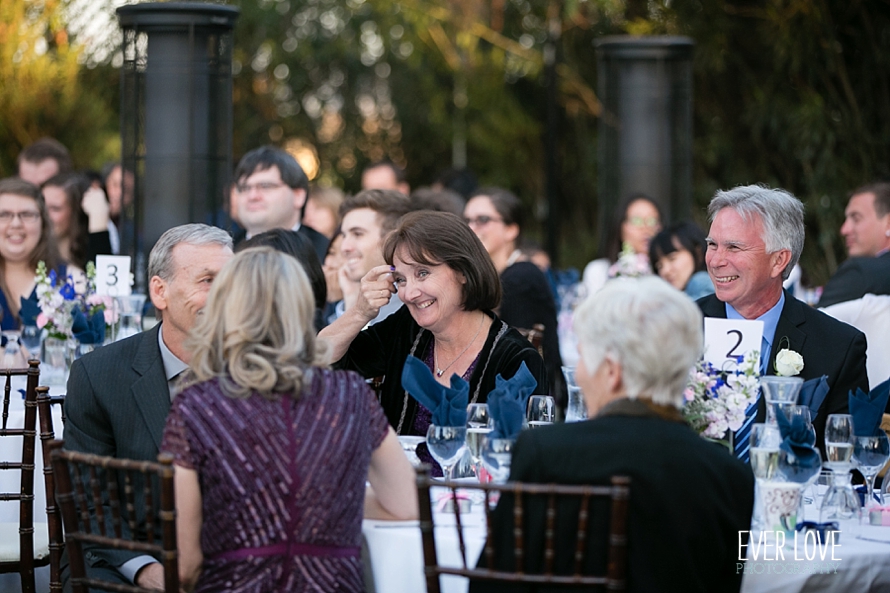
[417,466,630,593]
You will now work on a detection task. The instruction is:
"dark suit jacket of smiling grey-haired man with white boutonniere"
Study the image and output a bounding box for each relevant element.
[697,292,868,451]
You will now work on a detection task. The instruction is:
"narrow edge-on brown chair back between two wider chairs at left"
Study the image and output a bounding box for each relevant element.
[37,386,65,593]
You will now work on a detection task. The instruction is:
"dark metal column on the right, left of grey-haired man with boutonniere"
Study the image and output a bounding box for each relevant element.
[596,36,693,243]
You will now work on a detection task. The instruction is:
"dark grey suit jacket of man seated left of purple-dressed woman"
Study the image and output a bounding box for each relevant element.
[65,325,170,569]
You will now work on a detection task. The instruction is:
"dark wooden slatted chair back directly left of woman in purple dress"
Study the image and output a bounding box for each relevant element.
[51,441,179,593]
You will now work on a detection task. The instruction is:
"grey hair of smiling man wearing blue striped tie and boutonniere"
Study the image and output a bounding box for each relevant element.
[708,185,806,280]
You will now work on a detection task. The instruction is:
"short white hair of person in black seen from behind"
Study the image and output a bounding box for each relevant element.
[575,276,702,408]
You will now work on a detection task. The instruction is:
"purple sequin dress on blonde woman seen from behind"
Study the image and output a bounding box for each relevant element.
[161,368,388,593]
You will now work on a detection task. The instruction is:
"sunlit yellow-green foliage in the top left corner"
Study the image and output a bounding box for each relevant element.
[0,0,120,177]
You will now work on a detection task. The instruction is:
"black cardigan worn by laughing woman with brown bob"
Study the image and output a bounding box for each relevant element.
[336,306,550,434]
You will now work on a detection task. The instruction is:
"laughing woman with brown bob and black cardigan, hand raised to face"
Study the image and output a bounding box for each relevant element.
[319,211,549,435]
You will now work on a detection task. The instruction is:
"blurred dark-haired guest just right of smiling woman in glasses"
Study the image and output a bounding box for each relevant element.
[42,173,111,270]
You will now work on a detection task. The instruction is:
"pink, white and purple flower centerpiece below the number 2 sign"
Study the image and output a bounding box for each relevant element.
[683,350,760,450]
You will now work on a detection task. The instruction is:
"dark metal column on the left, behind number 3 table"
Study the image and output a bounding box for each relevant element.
[117,2,239,292]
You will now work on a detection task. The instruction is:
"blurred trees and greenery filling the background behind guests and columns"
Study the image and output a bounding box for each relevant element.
[0,0,890,283]
